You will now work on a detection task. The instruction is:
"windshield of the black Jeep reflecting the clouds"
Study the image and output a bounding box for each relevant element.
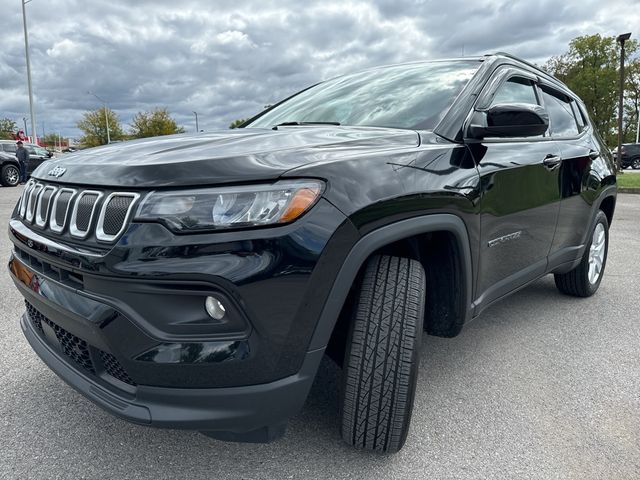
[248,60,480,130]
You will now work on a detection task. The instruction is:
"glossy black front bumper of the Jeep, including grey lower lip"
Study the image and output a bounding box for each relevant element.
[9,197,355,440]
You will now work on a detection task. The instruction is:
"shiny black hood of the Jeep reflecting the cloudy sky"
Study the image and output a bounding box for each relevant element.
[32,126,420,188]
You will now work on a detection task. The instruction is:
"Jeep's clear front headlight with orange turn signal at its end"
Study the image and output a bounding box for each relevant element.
[136,180,324,232]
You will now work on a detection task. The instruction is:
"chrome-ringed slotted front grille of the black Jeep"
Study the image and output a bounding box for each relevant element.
[18,180,140,242]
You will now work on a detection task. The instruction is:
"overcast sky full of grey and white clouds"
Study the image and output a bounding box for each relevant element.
[0,0,640,137]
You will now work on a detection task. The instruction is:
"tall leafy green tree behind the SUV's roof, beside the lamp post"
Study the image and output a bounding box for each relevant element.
[544,34,638,145]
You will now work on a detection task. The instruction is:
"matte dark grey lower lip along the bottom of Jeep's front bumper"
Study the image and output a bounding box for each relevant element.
[21,313,324,439]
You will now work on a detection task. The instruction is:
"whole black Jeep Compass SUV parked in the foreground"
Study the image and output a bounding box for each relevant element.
[9,54,616,452]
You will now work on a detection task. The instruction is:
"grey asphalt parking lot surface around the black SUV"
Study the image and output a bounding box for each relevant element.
[0,188,640,480]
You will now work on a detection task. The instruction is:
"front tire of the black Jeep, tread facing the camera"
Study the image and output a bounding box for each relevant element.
[340,256,426,453]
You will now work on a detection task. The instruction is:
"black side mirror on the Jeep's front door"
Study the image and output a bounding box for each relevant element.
[469,103,549,140]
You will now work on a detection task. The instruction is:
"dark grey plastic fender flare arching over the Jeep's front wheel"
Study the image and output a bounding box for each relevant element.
[308,214,473,351]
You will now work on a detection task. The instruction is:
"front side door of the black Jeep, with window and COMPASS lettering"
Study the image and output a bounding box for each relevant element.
[470,67,561,313]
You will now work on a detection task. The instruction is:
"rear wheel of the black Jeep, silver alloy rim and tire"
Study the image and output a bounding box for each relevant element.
[554,210,609,297]
